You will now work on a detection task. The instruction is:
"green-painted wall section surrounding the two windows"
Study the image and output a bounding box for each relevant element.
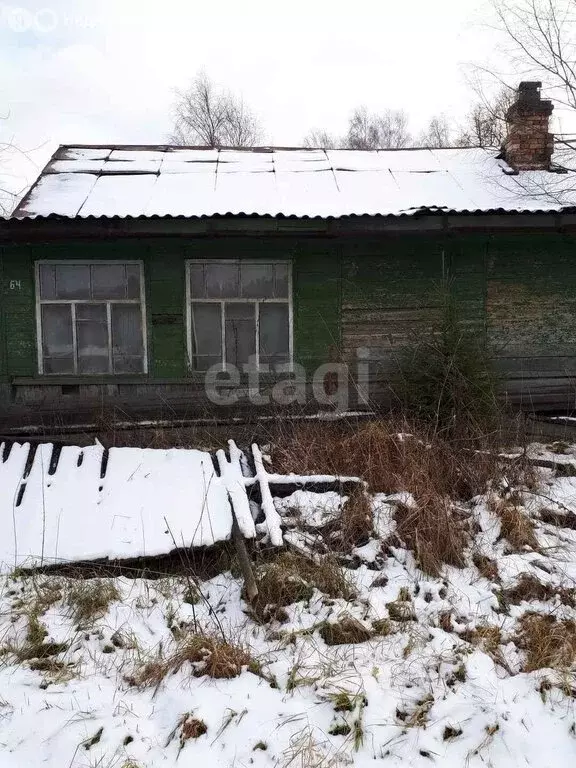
[0,237,341,380]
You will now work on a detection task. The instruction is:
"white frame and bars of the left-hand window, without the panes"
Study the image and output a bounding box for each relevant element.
[34,259,148,378]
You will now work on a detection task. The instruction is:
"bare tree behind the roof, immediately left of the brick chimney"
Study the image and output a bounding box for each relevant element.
[455,82,515,147]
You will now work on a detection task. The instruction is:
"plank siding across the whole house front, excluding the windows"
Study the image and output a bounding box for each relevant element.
[0,231,576,414]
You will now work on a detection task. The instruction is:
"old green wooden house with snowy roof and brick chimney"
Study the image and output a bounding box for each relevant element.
[0,82,576,432]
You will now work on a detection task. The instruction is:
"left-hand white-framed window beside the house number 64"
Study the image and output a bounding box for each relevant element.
[36,261,146,374]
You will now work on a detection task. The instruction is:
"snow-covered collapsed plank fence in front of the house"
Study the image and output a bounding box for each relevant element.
[0,441,358,570]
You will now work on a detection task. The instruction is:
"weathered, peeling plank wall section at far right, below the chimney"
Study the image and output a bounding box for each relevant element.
[486,234,576,409]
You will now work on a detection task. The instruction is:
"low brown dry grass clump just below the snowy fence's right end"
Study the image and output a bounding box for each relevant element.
[253,552,355,615]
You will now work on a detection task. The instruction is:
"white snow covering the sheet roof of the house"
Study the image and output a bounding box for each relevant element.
[14,142,576,218]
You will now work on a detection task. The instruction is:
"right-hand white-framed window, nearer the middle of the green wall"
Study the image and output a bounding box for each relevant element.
[187,261,292,371]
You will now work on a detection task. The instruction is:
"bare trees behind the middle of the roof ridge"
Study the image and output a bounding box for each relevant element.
[345,107,411,149]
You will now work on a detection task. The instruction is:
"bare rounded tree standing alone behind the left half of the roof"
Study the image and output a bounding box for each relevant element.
[170,72,262,147]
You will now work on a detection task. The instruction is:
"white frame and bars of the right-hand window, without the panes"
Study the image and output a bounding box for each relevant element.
[186,259,294,373]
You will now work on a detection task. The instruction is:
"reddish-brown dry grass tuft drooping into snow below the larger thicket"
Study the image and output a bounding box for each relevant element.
[394,495,468,576]
